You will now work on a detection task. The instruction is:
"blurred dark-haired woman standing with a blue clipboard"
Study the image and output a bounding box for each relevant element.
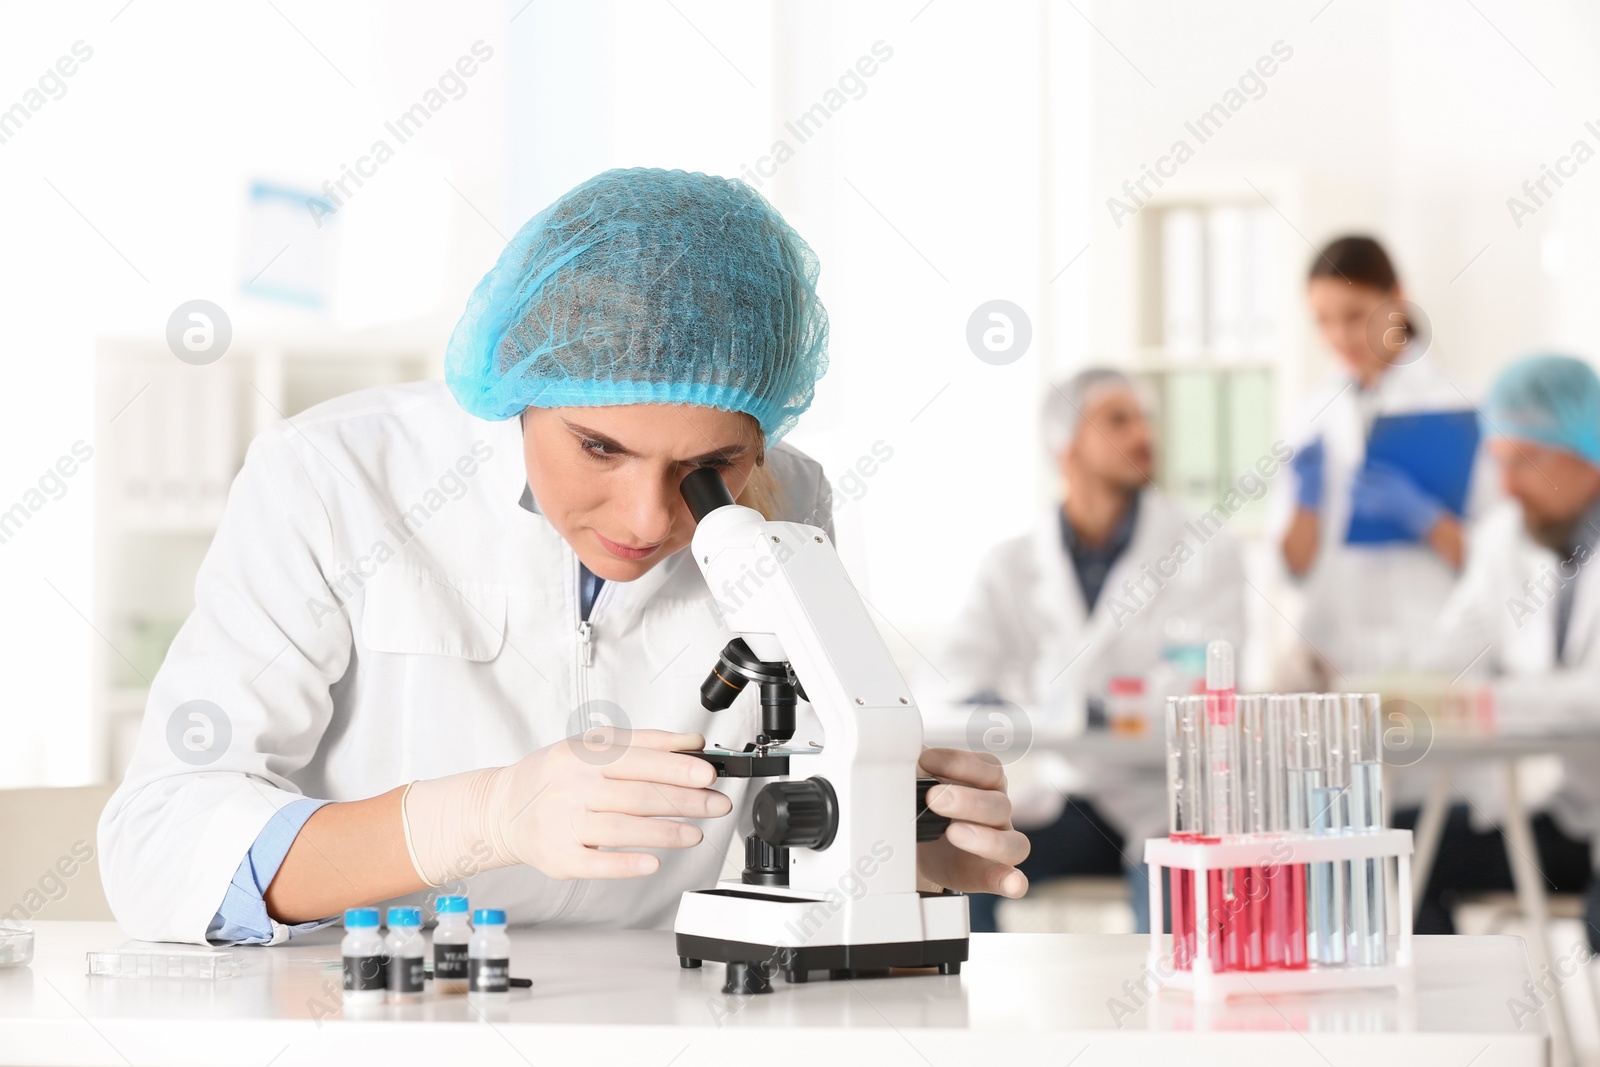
[1277,237,1485,685]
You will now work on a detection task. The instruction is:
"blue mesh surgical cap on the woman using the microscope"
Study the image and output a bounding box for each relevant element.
[445,170,827,443]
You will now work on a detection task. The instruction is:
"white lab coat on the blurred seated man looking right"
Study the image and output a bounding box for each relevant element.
[941,490,1245,857]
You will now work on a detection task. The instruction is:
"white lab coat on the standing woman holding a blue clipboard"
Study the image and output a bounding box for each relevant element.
[1272,357,1493,686]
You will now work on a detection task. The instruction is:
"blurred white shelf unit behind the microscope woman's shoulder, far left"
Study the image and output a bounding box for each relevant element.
[91,330,443,781]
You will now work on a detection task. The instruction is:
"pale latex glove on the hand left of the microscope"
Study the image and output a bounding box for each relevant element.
[402,726,733,886]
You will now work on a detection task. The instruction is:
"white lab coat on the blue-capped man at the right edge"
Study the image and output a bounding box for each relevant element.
[1426,501,1600,837]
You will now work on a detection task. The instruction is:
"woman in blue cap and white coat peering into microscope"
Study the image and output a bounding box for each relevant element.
[99,170,1027,944]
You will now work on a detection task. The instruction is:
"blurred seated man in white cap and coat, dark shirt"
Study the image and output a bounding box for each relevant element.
[944,370,1248,929]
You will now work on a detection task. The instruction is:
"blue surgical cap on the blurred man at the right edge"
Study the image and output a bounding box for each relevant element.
[1483,355,1600,467]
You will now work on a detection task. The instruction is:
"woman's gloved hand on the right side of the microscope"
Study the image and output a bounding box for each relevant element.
[917,749,1029,897]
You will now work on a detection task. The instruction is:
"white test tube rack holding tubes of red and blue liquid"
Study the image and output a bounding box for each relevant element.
[1144,830,1416,1001]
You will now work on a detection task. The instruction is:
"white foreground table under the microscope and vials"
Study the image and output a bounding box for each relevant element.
[0,923,1549,1067]
